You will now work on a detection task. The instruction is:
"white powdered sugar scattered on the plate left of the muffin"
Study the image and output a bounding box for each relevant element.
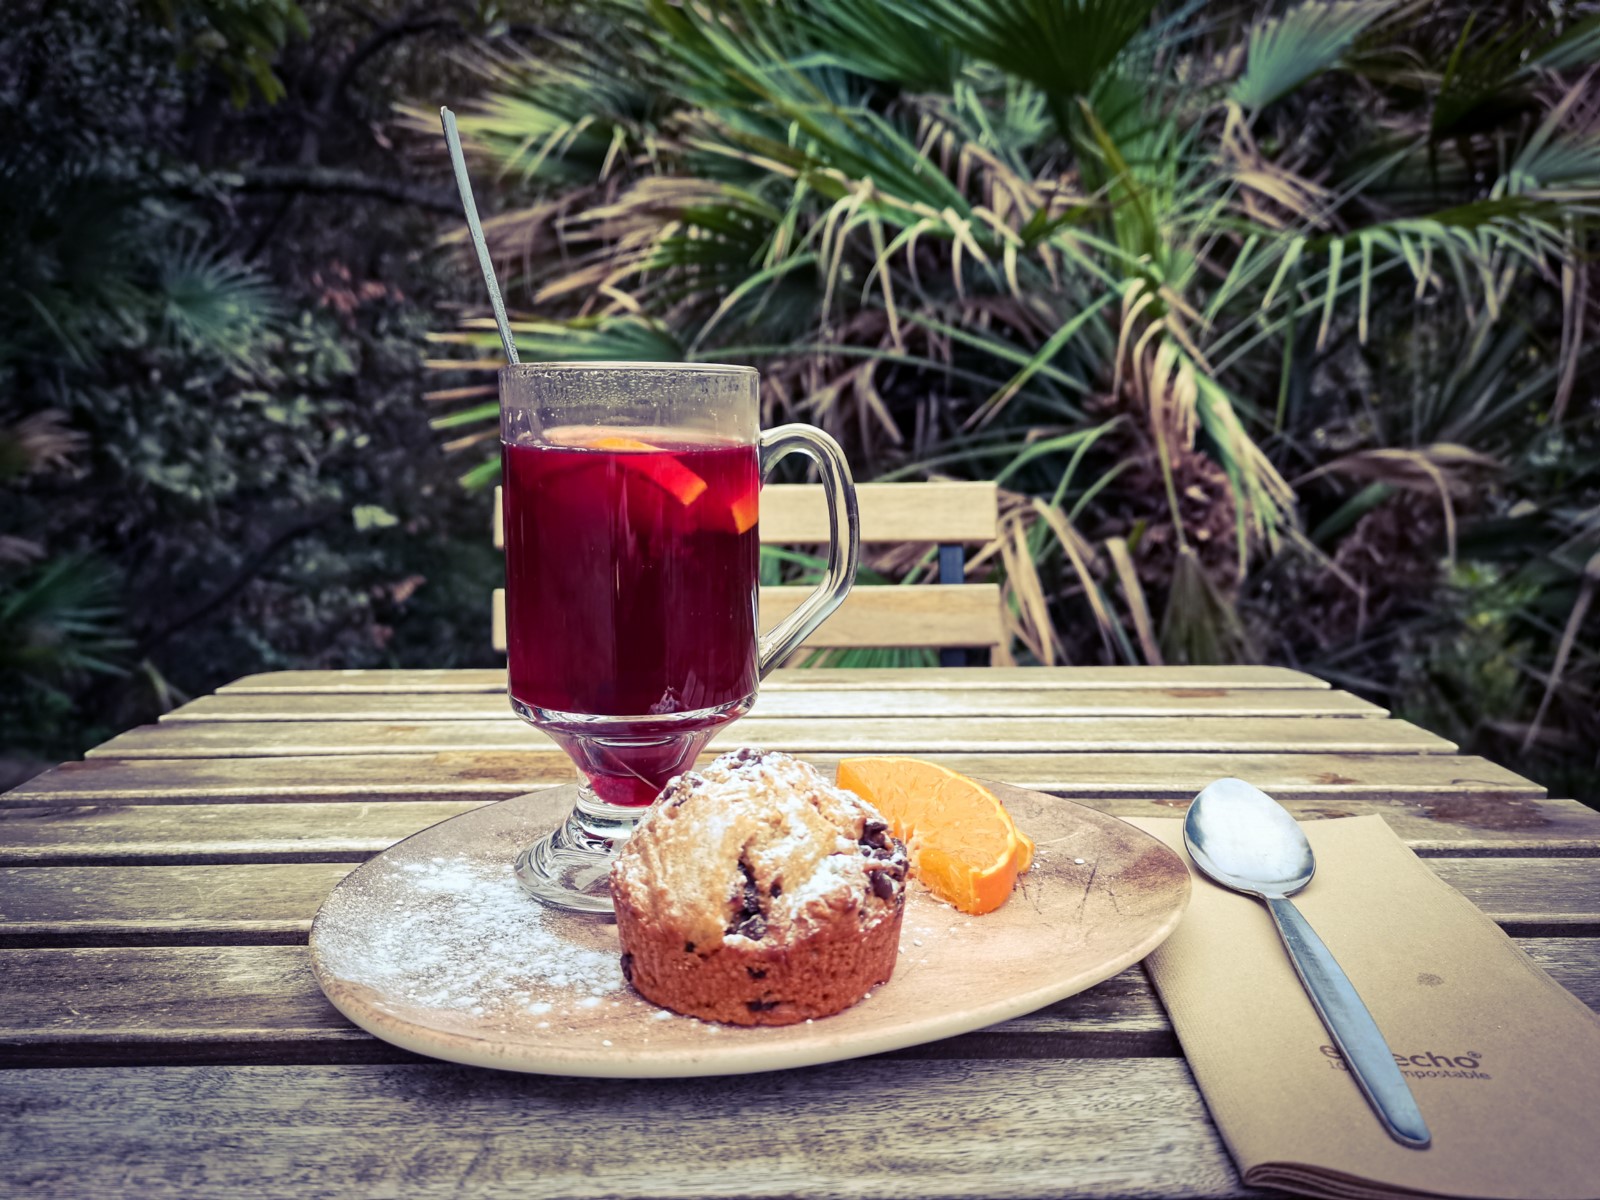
[318,858,626,1016]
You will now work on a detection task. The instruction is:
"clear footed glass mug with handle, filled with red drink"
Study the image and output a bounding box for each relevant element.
[499,363,859,912]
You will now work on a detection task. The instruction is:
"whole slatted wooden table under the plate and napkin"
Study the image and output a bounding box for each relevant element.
[0,667,1600,1198]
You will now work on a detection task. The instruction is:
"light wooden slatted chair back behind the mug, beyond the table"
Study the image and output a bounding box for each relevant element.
[494,483,1003,666]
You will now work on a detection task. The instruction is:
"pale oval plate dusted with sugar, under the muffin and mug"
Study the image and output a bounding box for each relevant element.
[310,784,1189,1078]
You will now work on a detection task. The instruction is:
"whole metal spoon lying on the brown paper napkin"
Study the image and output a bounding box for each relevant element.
[1184,779,1432,1149]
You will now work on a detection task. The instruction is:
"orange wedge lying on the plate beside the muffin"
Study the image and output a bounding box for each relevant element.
[838,758,1034,914]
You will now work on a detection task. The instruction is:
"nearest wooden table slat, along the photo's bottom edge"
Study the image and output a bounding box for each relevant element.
[0,1058,1262,1200]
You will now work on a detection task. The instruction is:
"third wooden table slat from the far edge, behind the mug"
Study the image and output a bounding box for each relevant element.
[86,717,1456,758]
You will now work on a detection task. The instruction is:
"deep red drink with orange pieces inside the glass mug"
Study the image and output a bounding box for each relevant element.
[502,429,760,805]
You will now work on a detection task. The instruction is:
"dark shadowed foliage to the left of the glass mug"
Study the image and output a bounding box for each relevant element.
[0,0,512,771]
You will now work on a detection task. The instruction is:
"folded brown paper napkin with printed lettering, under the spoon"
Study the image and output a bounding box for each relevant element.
[1133,816,1600,1200]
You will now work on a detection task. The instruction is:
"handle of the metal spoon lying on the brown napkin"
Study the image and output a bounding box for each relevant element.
[1264,896,1432,1149]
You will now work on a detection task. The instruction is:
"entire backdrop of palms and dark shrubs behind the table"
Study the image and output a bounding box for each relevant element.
[0,0,1600,809]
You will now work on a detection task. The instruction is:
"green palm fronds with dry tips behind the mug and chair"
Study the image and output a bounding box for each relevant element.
[437,0,1600,809]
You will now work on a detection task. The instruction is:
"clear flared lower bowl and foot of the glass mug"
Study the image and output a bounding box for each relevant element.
[512,696,755,912]
